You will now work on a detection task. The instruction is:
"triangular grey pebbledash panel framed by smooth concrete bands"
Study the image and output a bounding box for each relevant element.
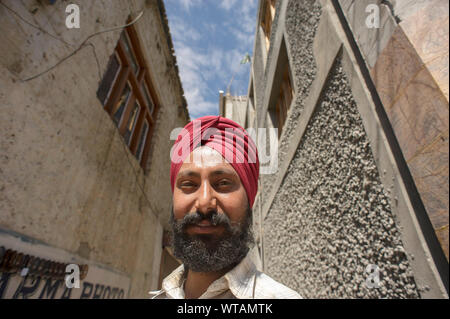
[264,57,419,298]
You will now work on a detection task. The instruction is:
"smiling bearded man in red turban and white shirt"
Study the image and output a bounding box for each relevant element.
[150,116,301,299]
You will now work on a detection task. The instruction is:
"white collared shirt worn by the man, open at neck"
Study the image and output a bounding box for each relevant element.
[149,254,302,299]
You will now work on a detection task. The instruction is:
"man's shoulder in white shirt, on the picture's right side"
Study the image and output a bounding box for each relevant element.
[255,271,303,299]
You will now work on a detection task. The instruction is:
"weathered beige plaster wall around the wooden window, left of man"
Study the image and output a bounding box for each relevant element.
[0,0,189,298]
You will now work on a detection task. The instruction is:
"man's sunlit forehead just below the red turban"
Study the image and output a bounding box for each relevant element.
[179,146,237,175]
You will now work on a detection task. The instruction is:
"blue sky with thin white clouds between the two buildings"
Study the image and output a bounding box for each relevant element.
[164,0,258,119]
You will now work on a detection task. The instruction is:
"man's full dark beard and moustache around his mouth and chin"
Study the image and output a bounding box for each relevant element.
[170,207,254,272]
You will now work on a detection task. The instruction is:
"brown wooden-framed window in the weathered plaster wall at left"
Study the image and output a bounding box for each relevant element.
[97,26,159,168]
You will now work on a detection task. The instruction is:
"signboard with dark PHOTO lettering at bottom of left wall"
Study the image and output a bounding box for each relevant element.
[0,229,130,299]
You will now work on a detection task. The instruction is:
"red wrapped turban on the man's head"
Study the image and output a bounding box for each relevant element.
[170,116,259,207]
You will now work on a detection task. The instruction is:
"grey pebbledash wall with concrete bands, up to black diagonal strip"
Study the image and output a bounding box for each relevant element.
[246,0,445,298]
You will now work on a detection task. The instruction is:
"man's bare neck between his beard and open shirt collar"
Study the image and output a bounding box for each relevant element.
[184,267,233,299]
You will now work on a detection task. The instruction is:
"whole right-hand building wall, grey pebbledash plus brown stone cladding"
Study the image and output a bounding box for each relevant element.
[237,0,448,298]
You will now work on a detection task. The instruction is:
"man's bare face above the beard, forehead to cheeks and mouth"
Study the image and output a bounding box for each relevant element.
[173,146,248,236]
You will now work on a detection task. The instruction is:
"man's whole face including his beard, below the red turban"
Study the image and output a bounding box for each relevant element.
[171,147,254,272]
